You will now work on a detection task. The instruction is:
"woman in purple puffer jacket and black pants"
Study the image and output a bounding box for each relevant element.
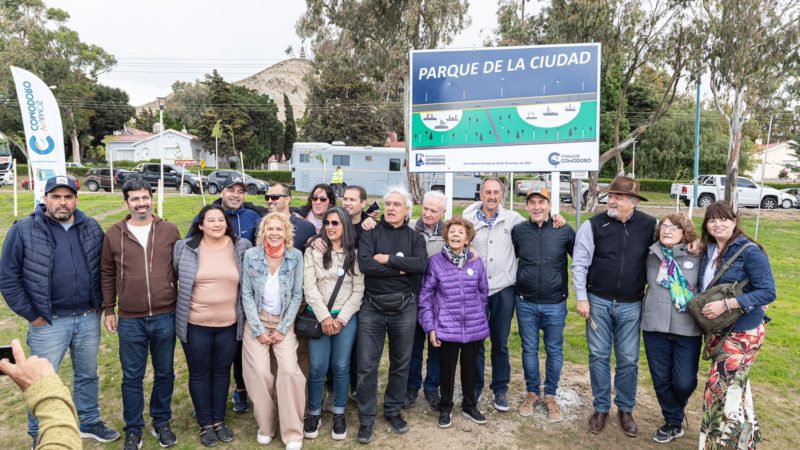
[419,217,489,428]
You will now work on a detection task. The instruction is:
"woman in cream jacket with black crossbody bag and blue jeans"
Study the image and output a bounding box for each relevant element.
[303,207,364,440]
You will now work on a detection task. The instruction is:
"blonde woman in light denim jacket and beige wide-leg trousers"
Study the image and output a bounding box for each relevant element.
[242,213,306,450]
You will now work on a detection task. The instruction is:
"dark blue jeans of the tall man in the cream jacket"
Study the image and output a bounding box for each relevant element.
[475,286,516,397]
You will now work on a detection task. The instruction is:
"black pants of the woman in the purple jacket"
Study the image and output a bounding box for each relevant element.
[439,341,483,412]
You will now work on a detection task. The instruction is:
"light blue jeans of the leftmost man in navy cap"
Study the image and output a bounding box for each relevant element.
[28,311,100,437]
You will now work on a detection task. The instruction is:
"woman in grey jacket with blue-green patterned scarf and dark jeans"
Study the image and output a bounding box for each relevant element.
[642,213,703,443]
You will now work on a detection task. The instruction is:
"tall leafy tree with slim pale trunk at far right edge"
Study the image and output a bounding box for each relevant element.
[696,0,800,209]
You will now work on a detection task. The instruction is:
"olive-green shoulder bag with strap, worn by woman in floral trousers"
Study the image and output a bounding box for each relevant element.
[686,242,755,360]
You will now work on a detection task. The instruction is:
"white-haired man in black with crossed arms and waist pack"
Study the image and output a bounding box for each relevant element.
[357,188,428,444]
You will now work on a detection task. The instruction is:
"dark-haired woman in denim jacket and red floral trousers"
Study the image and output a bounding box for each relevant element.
[700,202,775,449]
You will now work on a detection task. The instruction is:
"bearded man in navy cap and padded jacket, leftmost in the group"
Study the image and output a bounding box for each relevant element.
[0,175,119,447]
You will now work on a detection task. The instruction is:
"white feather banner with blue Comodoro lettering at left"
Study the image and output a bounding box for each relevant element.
[11,66,67,203]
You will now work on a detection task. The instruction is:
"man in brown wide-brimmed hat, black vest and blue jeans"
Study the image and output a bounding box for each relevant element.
[572,176,657,437]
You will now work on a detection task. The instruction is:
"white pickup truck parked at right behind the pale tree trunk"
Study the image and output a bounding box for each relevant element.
[670,175,794,209]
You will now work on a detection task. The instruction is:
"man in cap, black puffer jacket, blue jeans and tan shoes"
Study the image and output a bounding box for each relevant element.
[511,187,575,422]
